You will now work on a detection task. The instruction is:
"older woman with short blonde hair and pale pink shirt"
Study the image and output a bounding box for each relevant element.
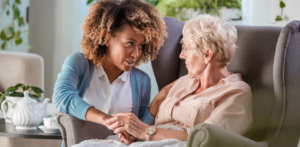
[106,14,252,144]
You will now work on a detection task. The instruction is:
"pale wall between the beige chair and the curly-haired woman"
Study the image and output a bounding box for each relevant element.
[29,0,88,98]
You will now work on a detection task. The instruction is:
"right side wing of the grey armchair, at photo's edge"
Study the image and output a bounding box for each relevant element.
[266,21,300,147]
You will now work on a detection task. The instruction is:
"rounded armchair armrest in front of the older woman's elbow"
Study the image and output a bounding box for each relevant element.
[187,123,268,147]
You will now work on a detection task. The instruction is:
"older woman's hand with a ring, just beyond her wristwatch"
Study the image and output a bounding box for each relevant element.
[105,113,149,140]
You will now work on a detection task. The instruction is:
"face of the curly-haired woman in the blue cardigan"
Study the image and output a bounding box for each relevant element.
[106,25,145,71]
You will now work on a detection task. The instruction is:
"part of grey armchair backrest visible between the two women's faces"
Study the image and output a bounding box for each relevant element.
[151,17,186,88]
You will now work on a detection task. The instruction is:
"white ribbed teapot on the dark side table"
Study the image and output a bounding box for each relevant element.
[1,91,50,129]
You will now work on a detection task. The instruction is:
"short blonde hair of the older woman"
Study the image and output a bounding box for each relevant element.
[183,14,237,65]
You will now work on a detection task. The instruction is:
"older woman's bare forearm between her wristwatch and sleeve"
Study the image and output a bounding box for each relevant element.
[150,128,188,141]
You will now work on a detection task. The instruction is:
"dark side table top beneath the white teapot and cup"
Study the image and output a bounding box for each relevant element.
[0,118,62,139]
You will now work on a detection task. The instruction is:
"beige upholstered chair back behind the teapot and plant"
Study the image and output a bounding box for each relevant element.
[0,51,44,92]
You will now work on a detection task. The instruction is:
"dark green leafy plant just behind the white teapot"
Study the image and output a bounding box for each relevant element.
[0,83,44,122]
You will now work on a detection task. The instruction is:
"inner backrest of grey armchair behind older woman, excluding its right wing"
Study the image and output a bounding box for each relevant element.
[152,17,292,145]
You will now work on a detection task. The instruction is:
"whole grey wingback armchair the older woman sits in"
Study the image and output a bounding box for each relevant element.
[57,17,300,147]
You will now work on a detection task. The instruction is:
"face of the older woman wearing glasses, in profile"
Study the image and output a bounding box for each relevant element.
[179,40,206,77]
